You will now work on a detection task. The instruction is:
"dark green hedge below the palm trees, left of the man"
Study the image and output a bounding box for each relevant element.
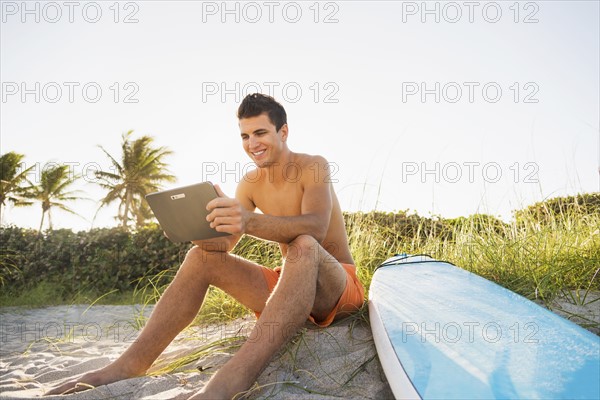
[0,225,189,295]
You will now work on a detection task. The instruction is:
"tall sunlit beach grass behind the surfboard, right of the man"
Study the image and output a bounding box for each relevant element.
[349,203,600,312]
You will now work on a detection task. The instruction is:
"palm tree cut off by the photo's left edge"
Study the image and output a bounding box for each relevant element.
[0,151,34,221]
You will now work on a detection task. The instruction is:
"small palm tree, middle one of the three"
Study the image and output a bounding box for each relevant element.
[27,165,83,233]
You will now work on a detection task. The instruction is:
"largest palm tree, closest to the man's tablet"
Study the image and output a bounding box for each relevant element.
[96,131,175,229]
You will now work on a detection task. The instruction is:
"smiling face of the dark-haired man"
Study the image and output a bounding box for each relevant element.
[239,113,287,168]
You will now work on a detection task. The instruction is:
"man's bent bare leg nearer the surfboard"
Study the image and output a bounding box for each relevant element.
[190,235,347,400]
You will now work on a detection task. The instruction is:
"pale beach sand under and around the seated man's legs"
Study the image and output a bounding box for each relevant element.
[0,306,393,400]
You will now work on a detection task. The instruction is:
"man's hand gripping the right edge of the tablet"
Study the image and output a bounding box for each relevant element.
[206,185,249,235]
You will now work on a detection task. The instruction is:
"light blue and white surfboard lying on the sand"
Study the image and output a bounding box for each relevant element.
[369,255,600,399]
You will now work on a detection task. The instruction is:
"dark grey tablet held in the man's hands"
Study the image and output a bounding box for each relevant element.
[146,182,229,243]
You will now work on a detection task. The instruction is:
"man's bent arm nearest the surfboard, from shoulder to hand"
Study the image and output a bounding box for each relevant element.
[208,157,332,243]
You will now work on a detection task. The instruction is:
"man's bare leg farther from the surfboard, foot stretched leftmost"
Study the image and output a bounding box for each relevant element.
[47,246,269,394]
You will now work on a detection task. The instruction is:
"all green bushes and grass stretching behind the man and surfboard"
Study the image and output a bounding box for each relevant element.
[0,193,600,320]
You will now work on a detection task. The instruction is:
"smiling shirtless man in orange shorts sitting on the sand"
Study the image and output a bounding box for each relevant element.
[48,94,364,399]
